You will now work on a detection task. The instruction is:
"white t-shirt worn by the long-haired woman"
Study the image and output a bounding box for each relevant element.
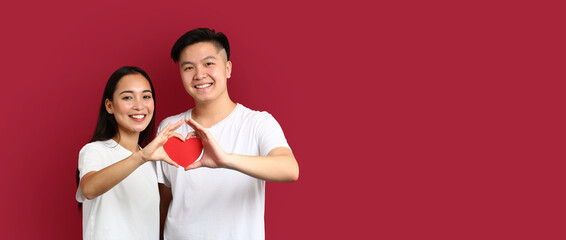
[76,139,159,240]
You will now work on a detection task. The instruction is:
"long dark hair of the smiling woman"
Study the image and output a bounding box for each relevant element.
[76,66,156,208]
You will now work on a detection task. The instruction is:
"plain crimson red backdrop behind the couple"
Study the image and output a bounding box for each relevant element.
[0,0,566,239]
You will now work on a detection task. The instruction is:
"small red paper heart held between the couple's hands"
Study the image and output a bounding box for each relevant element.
[163,137,203,168]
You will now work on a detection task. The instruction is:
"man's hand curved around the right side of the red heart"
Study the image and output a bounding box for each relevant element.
[185,119,232,170]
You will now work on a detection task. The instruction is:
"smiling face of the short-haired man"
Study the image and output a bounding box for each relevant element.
[179,42,232,103]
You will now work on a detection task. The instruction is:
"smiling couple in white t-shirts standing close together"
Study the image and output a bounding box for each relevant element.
[76,28,299,240]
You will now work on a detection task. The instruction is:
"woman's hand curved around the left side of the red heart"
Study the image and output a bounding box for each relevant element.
[140,119,185,167]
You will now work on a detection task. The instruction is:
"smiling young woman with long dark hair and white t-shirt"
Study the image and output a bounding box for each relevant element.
[76,66,184,240]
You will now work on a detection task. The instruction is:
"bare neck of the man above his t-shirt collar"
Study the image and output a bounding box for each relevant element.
[191,98,236,128]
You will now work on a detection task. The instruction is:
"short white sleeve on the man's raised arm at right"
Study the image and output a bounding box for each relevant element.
[256,112,290,156]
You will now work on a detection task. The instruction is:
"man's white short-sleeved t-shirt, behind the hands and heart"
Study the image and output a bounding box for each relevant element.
[157,104,289,240]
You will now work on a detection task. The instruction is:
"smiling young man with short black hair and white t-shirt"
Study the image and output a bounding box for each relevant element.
[157,28,299,240]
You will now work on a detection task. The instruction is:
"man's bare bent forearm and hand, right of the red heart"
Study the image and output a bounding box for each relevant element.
[185,119,299,182]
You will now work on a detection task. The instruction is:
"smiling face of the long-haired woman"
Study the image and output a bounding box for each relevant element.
[105,74,155,136]
